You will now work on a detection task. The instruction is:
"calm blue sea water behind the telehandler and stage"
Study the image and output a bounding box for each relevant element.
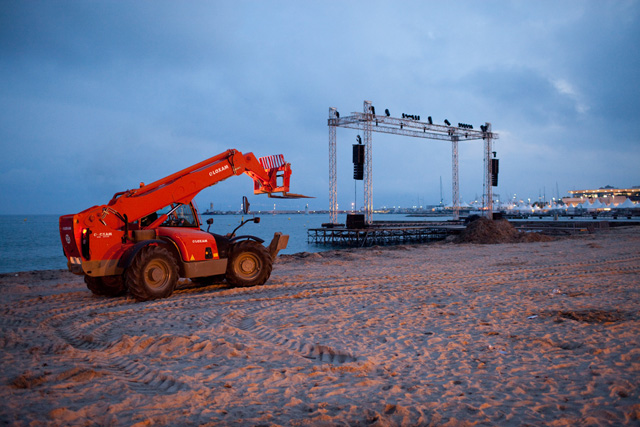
[0,213,440,273]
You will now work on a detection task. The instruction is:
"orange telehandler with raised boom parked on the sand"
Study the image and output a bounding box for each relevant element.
[60,149,305,301]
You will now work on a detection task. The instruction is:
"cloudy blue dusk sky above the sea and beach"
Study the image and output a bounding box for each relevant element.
[0,0,640,214]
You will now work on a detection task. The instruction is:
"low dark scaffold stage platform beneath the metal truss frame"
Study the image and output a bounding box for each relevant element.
[307,221,464,247]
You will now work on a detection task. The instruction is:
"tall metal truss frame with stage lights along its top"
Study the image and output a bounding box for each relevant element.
[328,101,498,224]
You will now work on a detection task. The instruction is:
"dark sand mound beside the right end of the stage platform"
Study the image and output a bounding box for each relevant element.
[457,217,553,244]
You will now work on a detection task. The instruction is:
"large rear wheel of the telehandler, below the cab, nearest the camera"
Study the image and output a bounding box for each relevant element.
[124,246,178,301]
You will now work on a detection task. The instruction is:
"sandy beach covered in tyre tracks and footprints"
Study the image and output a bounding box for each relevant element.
[0,228,640,426]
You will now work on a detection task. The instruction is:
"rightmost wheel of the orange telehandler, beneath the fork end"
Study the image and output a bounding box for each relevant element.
[226,240,273,287]
